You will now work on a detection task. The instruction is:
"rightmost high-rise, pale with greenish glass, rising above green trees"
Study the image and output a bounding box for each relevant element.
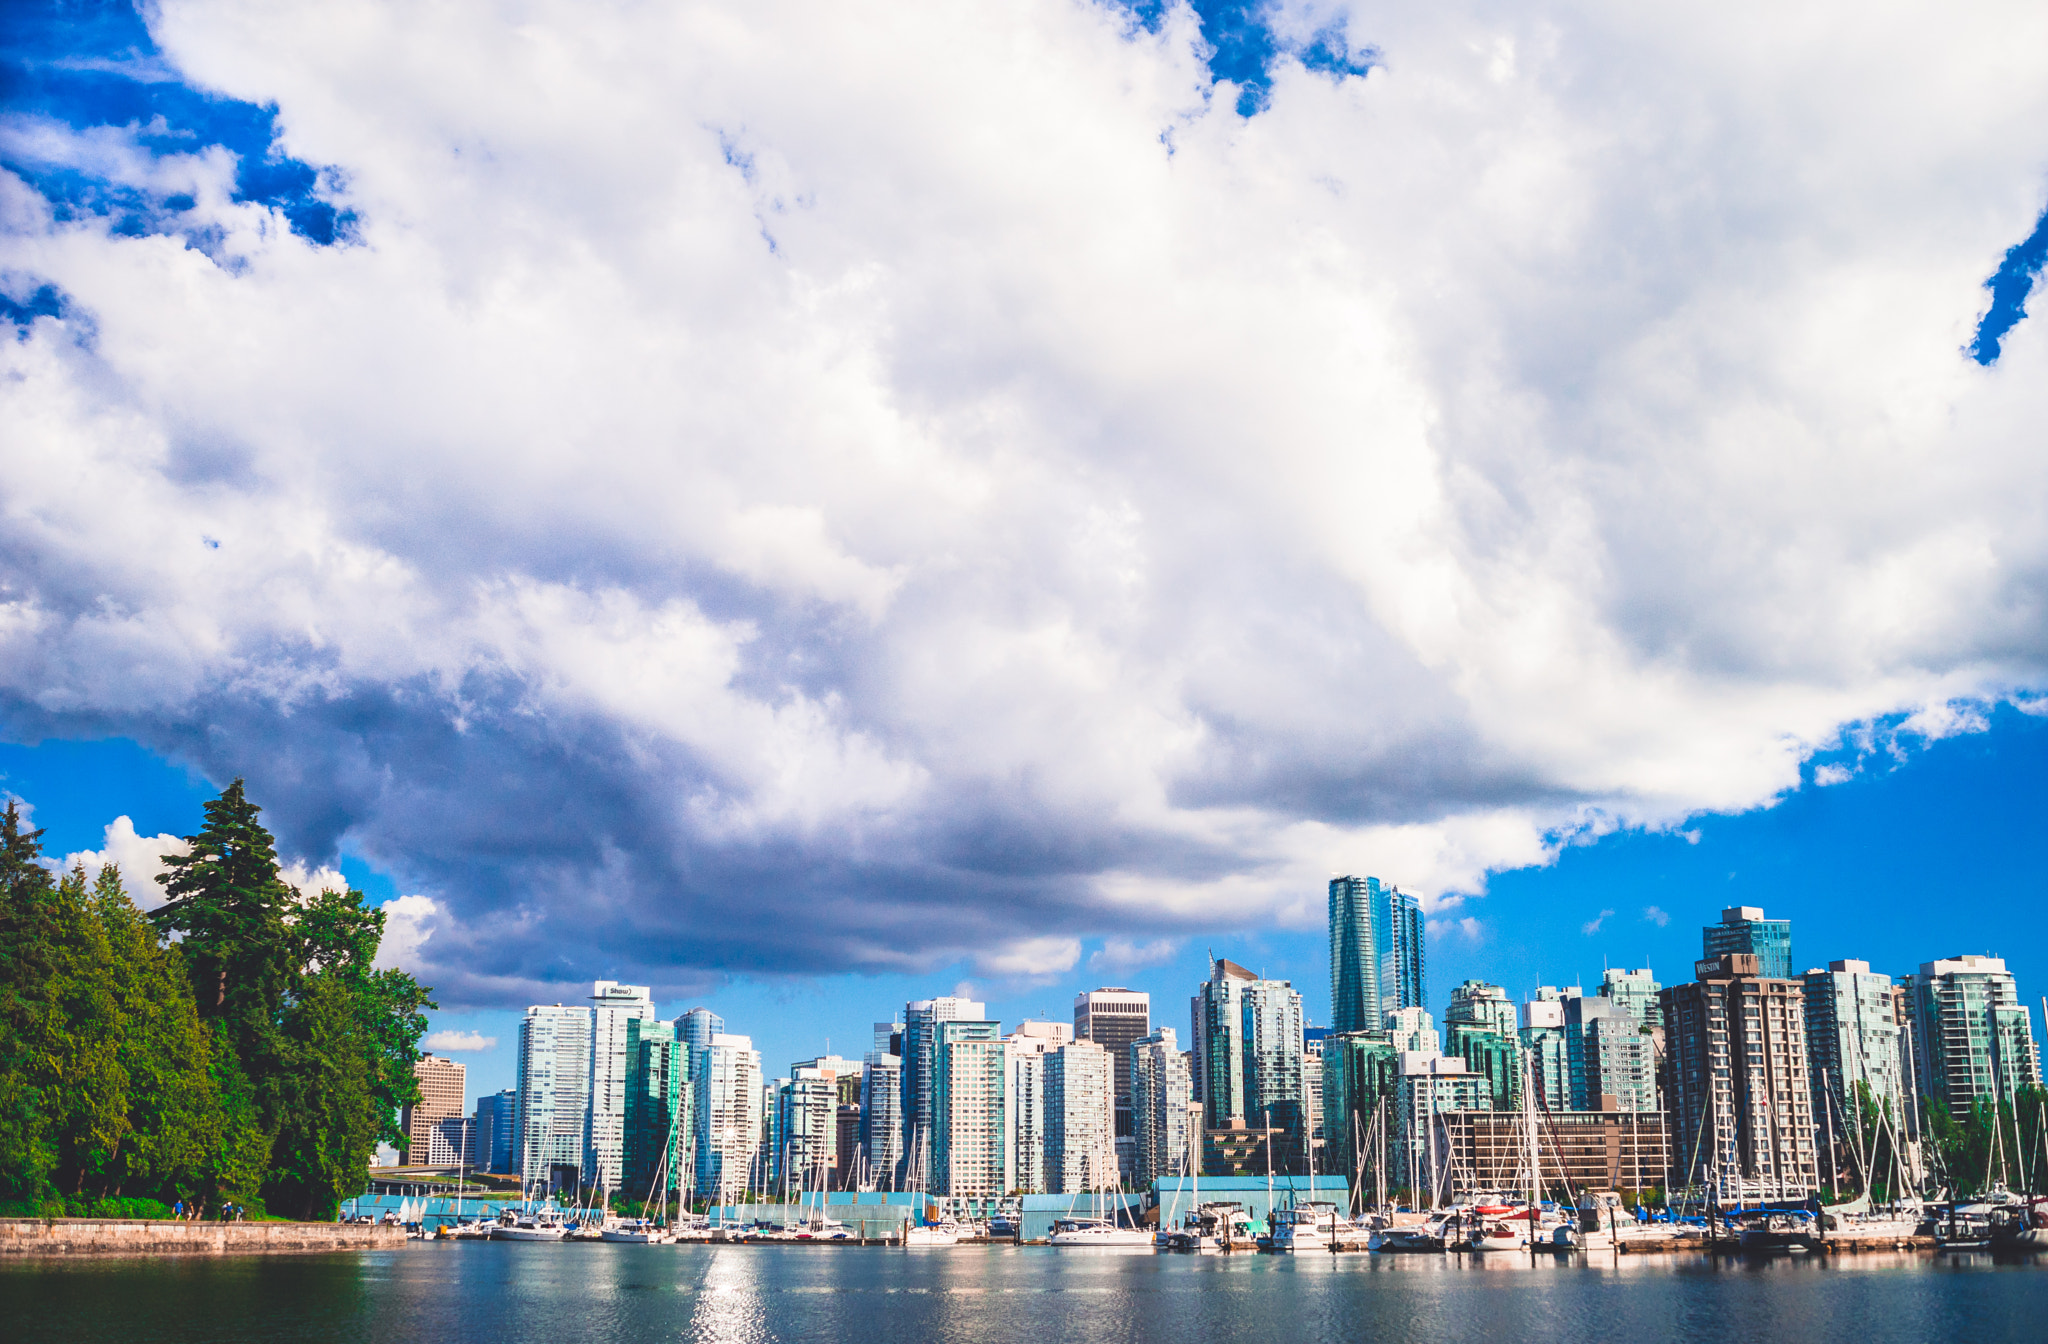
[1909,955,2042,1121]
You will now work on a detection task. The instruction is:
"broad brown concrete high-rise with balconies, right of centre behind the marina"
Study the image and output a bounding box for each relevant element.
[1659,953,1819,1203]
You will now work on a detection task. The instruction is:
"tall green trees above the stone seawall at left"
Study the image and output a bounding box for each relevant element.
[0,779,434,1219]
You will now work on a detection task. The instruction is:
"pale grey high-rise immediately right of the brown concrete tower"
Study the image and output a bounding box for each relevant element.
[1804,961,1907,1186]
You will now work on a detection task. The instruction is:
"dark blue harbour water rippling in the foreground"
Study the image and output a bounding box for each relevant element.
[0,1242,2048,1344]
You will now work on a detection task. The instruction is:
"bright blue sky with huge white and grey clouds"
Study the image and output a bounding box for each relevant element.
[0,0,2048,1106]
